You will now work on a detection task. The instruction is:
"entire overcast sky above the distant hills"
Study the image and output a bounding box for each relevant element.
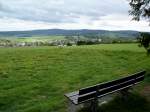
[0,0,150,31]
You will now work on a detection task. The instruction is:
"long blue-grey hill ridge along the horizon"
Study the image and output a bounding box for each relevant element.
[0,29,142,38]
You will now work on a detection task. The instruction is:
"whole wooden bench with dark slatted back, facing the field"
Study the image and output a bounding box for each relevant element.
[65,71,146,112]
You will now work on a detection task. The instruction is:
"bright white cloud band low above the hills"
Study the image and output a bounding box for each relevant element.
[0,17,150,31]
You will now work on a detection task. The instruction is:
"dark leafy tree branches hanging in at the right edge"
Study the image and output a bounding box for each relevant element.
[129,0,150,54]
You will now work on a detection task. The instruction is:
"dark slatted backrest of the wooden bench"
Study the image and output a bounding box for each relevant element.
[78,71,146,103]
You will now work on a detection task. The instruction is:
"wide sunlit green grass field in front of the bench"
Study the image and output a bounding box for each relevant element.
[0,44,150,112]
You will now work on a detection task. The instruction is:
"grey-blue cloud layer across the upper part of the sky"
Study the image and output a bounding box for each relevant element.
[0,0,128,23]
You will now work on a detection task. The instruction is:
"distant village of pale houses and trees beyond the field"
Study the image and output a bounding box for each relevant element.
[0,39,102,47]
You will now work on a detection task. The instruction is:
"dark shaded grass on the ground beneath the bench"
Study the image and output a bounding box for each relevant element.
[79,93,150,112]
